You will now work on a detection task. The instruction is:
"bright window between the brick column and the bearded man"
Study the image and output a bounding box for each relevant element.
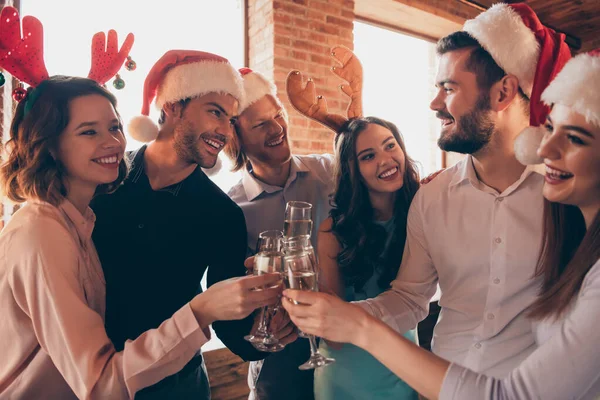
[354,21,442,176]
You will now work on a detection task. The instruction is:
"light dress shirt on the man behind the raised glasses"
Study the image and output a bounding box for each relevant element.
[228,154,333,254]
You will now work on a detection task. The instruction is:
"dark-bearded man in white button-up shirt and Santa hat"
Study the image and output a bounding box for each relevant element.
[359,4,569,377]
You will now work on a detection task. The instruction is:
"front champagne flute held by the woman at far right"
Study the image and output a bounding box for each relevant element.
[284,251,335,370]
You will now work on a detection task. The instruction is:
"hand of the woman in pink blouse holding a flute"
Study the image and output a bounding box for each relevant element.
[190,273,282,327]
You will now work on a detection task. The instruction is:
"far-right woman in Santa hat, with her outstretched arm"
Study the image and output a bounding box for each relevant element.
[283,50,600,400]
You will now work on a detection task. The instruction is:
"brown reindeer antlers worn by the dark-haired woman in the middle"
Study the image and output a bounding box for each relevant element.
[286,46,363,132]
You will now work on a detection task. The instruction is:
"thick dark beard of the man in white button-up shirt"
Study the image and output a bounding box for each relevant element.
[436,94,496,154]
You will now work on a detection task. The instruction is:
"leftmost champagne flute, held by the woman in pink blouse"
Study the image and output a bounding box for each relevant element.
[244,230,285,352]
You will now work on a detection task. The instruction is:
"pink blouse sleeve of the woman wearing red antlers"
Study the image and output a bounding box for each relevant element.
[9,219,207,399]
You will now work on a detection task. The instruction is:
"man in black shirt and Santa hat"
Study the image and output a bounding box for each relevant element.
[92,51,278,400]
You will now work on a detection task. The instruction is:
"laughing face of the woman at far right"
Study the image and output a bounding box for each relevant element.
[538,104,600,216]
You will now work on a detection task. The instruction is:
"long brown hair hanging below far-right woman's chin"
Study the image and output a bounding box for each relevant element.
[529,200,600,319]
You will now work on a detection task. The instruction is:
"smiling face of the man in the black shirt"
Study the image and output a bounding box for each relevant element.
[173,93,238,168]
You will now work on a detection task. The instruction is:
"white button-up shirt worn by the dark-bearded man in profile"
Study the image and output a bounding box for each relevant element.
[359,156,543,377]
